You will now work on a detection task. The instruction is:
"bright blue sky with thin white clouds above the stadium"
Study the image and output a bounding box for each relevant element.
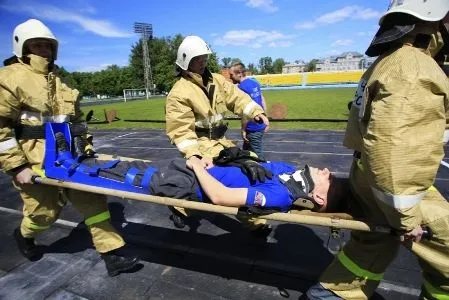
[0,0,390,72]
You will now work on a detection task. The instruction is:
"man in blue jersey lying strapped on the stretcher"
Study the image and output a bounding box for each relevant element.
[51,133,347,213]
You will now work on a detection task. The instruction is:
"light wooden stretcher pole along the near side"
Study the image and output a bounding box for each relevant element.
[34,177,391,233]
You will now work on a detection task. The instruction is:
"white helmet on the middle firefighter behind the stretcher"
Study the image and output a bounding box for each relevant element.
[176,35,212,71]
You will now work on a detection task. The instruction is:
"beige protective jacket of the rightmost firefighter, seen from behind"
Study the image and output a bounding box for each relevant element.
[344,45,449,231]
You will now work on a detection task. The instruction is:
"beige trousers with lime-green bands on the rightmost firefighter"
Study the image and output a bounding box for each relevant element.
[320,159,449,299]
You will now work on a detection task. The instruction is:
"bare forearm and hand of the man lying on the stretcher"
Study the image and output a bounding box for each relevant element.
[187,156,248,207]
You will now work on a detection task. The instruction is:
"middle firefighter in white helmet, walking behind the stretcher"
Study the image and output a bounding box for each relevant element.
[165,36,269,235]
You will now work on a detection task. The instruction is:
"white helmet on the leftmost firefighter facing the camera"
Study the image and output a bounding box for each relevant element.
[12,19,58,60]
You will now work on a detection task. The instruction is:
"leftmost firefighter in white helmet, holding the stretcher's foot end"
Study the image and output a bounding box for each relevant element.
[0,19,138,276]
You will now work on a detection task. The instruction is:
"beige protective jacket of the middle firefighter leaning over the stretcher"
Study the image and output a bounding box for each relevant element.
[165,70,264,158]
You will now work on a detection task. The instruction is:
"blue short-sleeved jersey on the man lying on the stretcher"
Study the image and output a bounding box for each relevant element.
[200,162,296,211]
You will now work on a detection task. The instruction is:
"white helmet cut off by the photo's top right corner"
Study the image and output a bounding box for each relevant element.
[379,0,449,25]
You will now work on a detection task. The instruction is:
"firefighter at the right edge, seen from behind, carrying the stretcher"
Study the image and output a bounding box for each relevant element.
[303,0,449,299]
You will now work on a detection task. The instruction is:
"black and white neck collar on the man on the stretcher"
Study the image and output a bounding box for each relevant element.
[279,165,321,211]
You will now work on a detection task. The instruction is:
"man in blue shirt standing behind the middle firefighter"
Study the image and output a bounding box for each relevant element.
[229,62,268,158]
